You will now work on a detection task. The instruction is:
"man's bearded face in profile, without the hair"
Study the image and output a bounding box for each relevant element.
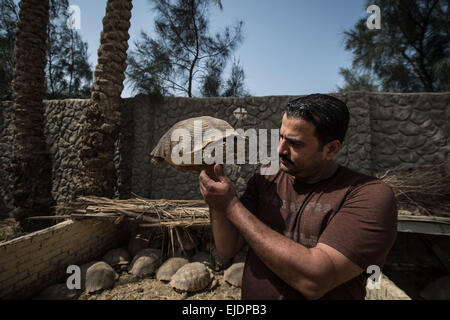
[278,114,326,181]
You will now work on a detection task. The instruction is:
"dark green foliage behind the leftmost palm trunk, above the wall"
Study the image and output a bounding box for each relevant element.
[0,0,92,100]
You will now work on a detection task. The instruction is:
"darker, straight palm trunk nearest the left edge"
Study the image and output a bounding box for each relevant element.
[12,0,54,232]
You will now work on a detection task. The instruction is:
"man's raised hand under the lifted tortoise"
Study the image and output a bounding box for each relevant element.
[199,164,239,214]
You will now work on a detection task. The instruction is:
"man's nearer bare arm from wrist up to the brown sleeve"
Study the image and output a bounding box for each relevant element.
[227,200,363,299]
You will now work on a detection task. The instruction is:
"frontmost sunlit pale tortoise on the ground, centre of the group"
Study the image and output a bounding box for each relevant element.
[169,262,217,293]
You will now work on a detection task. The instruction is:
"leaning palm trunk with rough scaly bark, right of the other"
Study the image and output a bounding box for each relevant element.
[77,0,133,197]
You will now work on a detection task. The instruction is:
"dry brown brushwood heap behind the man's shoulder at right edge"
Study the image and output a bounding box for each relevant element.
[379,161,450,217]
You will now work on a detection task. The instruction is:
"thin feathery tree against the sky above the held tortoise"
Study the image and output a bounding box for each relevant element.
[126,0,250,97]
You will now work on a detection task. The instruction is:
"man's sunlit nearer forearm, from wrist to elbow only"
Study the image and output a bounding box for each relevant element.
[227,202,333,299]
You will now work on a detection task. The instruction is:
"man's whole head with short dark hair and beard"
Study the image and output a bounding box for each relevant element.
[278,94,349,181]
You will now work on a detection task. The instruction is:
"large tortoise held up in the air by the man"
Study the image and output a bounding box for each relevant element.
[150,116,246,172]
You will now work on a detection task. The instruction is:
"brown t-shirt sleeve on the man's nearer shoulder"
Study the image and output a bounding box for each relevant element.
[319,180,397,270]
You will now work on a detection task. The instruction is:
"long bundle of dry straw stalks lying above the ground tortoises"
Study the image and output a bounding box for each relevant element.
[56,196,210,228]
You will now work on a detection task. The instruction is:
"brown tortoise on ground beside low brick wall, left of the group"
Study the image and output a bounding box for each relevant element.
[81,261,119,293]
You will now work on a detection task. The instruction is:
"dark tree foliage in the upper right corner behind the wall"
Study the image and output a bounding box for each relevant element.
[341,0,450,92]
